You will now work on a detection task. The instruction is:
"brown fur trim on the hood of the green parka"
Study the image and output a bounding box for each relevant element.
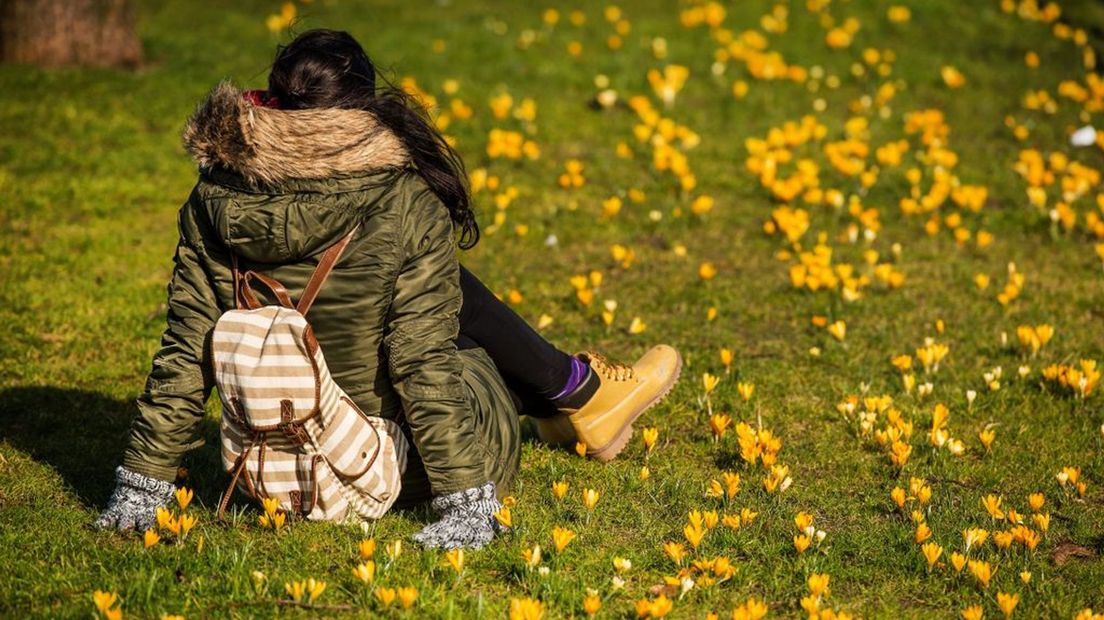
[183,82,410,183]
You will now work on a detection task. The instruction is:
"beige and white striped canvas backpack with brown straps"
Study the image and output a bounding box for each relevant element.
[211,223,407,521]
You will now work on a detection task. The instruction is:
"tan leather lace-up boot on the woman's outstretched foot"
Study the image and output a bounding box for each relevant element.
[560,344,682,461]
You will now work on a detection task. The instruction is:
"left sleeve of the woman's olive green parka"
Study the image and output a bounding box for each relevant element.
[123,204,220,481]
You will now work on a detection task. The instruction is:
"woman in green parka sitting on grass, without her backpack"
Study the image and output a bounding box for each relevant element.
[96,30,681,548]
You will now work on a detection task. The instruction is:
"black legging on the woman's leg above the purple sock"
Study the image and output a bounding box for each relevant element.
[456,266,571,417]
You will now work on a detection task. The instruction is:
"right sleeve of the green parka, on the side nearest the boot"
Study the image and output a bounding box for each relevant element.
[384,183,487,495]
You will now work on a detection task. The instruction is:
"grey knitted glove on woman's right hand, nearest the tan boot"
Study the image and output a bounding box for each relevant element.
[414,482,502,549]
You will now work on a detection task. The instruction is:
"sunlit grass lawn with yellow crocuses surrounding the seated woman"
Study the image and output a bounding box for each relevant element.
[0,0,1104,618]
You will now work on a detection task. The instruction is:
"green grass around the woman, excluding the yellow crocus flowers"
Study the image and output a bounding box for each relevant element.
[0,0,1104,618]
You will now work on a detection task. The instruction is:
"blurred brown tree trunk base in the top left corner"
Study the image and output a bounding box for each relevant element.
[0,0,142,68]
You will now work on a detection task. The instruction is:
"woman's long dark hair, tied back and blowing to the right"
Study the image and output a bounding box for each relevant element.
[268,29,479,249]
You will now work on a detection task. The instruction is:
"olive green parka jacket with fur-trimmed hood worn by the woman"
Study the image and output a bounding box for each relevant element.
[124,83,520,504]
